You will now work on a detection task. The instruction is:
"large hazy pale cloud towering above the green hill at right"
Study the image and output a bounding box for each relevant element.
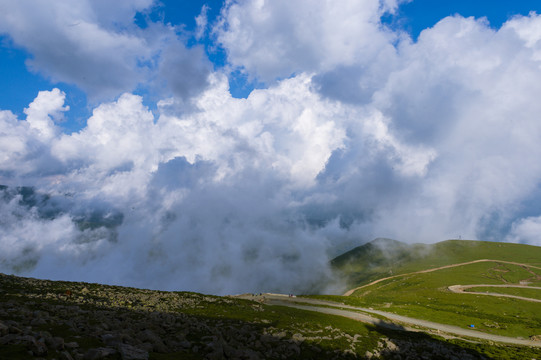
[360,16,541,240]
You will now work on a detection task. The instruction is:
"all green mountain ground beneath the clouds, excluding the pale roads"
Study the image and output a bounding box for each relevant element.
[0,239,541,360]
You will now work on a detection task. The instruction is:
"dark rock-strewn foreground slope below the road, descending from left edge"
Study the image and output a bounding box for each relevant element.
[0,274,532,360]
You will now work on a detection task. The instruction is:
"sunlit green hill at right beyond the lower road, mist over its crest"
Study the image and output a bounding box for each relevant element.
[320,240,541,338]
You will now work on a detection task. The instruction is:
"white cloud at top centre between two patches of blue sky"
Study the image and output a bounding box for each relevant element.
[214,0,396,82]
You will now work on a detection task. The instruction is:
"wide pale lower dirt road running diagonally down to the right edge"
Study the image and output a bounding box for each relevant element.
[248,294,541,347]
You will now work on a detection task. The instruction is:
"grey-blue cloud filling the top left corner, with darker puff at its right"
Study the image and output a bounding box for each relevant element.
[0,0,210,101]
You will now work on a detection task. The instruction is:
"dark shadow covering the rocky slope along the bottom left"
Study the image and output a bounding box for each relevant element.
[0,274,506,359]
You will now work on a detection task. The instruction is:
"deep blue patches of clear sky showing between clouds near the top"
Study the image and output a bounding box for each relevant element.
[0,0,541,132]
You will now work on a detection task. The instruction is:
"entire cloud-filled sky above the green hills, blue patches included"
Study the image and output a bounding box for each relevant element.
[0,0,541,294]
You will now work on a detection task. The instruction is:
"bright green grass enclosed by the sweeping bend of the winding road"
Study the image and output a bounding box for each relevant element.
[354,263,541,338]
